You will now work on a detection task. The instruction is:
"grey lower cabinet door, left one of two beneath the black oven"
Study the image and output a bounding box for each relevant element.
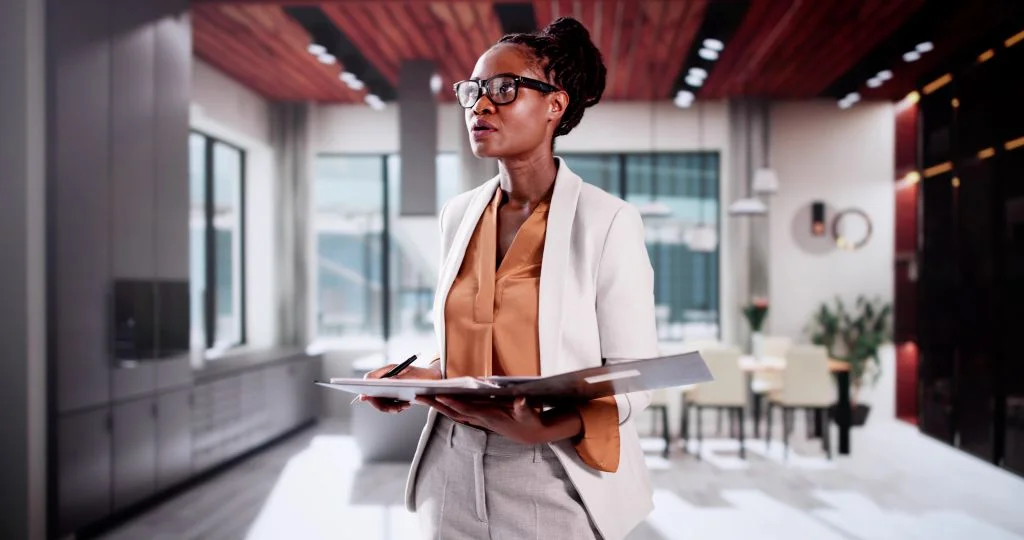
[113,398,157,510]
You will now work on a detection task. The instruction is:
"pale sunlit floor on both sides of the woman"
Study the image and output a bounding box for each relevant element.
[97,411,1024,540]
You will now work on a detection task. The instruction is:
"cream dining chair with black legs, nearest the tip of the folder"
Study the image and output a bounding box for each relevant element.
[682,346,746,458]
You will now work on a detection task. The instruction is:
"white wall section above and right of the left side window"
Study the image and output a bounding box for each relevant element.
[190,58,278,347]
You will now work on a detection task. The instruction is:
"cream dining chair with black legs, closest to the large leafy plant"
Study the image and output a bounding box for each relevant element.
[765,345,836,459]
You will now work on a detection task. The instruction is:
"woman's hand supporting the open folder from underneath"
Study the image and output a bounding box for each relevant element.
[417,396,583,445]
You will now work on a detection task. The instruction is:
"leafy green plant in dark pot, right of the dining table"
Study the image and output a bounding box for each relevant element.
[810,295,892,425]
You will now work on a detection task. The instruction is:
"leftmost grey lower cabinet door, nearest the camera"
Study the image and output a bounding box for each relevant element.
[54,408,111,535]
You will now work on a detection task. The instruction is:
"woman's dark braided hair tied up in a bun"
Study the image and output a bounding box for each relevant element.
[499,17,607,137]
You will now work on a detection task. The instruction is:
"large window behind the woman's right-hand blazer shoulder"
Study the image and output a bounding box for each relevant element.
[564,153,719,340]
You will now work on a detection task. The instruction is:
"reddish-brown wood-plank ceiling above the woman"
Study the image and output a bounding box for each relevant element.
[193,0,1011,102]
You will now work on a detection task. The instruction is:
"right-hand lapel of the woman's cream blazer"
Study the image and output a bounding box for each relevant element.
[537,158,583,375]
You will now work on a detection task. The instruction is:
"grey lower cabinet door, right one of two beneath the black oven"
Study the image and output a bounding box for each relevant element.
[157,388,193,489]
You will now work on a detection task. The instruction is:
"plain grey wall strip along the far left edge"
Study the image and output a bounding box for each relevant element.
[0,0,46,540]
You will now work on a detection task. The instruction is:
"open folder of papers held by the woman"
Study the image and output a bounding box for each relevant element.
[313,351,714,406]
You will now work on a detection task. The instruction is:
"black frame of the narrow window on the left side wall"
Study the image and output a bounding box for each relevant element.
[189,129,248,351]
